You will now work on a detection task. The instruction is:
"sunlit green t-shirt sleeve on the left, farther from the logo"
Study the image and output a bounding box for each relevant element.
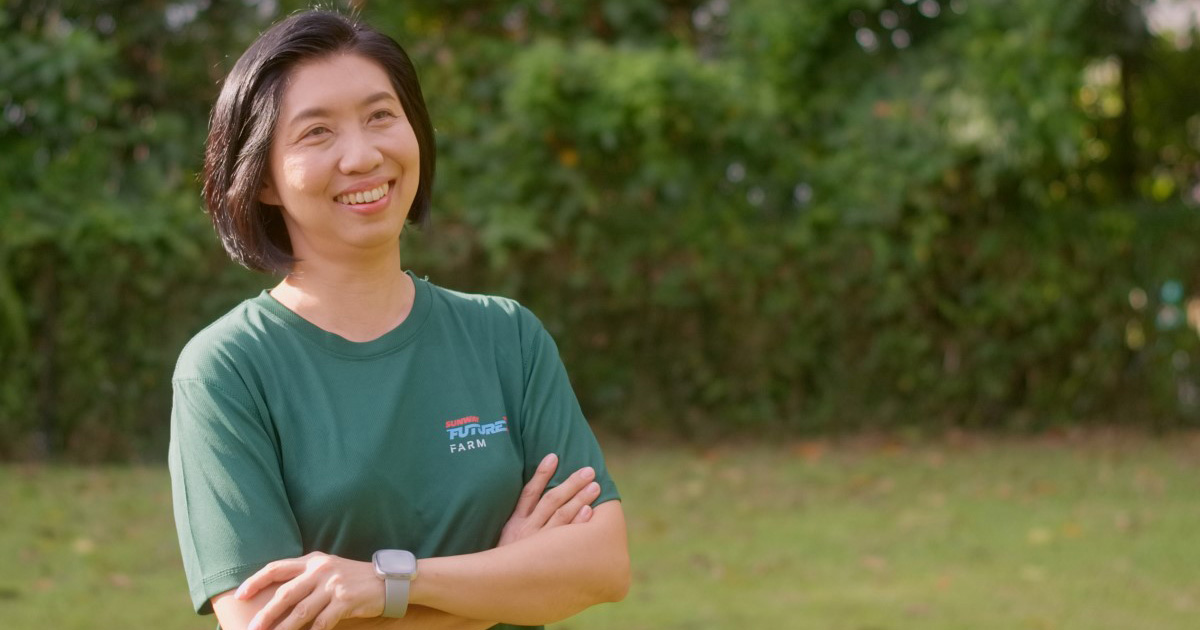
[168,379,304,614]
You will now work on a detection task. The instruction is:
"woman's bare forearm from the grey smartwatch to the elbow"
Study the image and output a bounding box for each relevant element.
[410,500,630,625]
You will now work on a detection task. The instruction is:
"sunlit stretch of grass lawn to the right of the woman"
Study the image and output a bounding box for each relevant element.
[556,436,1200,630]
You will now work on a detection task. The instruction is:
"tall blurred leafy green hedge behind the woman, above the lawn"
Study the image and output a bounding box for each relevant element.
[0,0,1200,461]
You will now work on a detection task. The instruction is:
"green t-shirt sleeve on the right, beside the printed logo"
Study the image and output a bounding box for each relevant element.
[521,308,620,505]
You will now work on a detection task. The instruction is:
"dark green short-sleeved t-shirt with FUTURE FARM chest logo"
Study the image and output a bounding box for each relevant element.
[169,277,618,628]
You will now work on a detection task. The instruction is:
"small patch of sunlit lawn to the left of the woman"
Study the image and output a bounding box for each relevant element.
[0,466,205,630]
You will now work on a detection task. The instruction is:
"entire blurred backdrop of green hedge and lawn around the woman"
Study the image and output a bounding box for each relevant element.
[0,0,1200,630]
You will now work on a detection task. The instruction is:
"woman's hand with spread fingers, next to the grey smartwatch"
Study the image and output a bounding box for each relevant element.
[235,551,384,630]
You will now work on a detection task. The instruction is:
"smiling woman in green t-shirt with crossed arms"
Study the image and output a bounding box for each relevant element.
[169,11,629,630]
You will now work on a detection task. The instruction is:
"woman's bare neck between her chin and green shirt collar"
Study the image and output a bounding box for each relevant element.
[270,252,415,342]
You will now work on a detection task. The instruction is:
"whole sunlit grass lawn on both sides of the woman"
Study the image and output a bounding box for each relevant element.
[0,433,1200,630]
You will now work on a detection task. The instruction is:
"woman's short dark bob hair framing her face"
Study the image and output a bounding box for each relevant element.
[204,11,437,272]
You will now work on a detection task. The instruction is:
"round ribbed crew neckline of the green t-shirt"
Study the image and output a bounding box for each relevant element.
[251,271,432,359]
